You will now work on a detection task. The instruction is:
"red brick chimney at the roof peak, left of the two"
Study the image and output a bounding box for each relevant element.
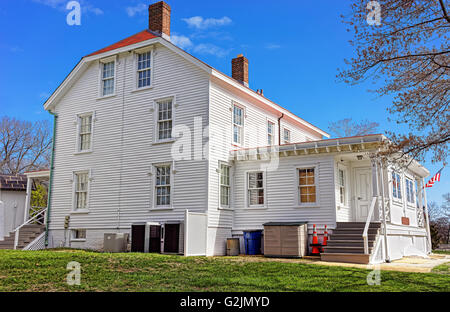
[148,1,170,40]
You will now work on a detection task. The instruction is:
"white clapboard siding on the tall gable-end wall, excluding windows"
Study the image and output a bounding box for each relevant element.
[50,42,209,229]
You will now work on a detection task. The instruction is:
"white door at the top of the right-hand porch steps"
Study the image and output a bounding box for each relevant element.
[354,168,372,222]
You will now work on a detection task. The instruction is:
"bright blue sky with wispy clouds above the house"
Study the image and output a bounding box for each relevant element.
[0,0,450,202]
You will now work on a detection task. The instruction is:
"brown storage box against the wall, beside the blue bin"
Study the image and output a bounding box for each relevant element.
[263,222,308,258]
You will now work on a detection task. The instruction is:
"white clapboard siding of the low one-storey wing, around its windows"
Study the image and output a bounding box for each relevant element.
[233,156,336,231]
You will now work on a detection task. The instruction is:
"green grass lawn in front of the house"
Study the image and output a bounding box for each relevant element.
[0,250,450,292]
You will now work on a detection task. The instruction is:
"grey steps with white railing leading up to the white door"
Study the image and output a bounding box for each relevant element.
[320,222,381,264]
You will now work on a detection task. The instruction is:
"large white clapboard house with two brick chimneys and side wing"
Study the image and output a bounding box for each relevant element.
[29,2,430,263]
